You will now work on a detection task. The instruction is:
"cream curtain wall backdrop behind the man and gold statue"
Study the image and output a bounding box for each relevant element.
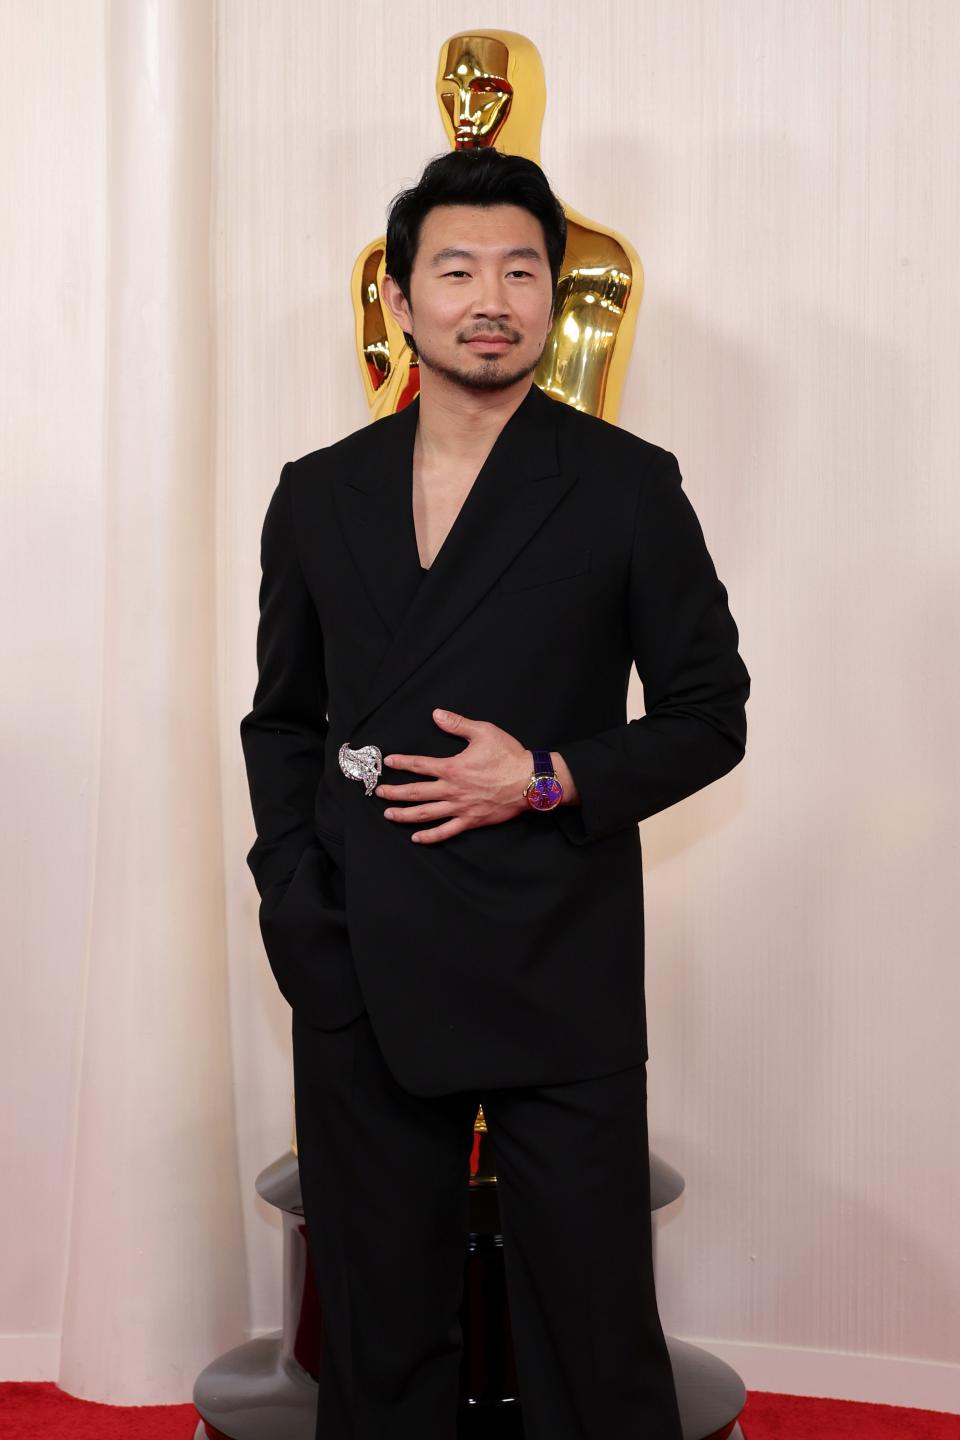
[0,0,960,1411]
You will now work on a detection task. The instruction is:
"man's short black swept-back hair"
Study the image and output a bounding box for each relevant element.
[386,145,567,301]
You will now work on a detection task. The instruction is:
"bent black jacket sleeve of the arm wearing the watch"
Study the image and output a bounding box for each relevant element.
[553,451,750,844]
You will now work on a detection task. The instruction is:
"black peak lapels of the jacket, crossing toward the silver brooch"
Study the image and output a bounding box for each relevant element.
[337,384,576,744]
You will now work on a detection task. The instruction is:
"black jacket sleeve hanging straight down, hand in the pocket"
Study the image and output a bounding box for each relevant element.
[240,462,328,897]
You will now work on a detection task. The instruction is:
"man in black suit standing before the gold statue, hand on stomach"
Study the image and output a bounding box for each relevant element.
[240,150,750,1440]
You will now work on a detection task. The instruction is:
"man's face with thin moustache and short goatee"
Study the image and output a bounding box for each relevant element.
[384,204,553,390]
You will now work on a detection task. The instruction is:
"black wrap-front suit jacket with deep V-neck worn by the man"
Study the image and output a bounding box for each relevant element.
[240,384,750,1094]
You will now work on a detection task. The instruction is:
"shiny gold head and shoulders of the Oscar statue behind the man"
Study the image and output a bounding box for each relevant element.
[350,30,643,420]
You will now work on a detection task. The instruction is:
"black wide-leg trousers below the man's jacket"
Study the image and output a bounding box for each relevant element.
[292,990,682,1440]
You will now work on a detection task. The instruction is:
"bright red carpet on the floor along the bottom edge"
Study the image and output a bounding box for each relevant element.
[0,1381,960,1440]
